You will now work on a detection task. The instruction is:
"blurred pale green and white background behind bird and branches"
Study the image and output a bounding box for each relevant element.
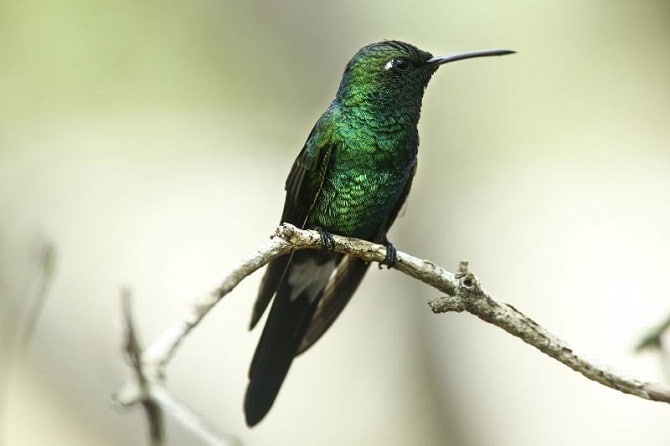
[0,0,670,446]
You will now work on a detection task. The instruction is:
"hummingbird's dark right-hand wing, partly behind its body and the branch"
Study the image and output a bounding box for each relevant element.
[298,161,416,354]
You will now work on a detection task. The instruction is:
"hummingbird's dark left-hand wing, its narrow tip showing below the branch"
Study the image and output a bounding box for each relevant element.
[250,117,333,329]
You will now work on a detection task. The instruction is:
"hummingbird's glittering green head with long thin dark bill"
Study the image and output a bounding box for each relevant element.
[335,40,513,114]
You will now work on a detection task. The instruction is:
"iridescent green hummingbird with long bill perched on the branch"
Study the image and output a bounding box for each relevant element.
[244,40,514,426]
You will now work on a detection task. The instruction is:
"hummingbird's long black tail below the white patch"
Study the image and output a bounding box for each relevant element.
[244,281,317,426]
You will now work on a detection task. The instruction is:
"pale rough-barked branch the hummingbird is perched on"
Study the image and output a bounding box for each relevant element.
[115,224,670,442]
